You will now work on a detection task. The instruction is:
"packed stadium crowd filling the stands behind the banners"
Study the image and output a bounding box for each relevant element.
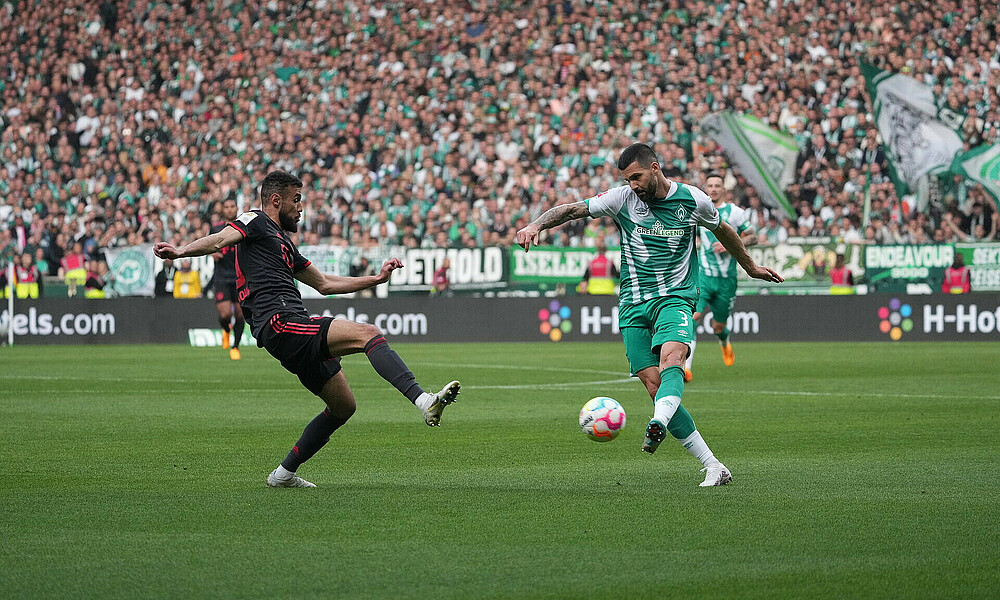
[0,0,1000,290]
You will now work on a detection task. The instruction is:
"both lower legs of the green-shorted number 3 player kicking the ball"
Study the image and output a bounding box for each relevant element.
[637,342,733,487]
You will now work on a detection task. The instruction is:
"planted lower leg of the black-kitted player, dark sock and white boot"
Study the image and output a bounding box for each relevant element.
[267,367,357,487]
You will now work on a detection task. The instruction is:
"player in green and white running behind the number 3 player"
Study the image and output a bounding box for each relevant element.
[684,173,757,381]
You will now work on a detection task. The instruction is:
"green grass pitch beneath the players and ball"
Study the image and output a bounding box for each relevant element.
[0,340,1000,599]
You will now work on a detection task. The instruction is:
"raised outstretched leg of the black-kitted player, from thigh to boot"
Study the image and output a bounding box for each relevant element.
[327,319,462,427]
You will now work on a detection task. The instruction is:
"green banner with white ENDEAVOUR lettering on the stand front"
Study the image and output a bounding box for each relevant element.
[865,244,955,293]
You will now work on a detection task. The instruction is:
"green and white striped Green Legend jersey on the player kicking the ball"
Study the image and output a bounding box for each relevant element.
[585,181,719,305]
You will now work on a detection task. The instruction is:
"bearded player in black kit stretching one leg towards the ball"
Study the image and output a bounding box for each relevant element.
[153,171,461,487]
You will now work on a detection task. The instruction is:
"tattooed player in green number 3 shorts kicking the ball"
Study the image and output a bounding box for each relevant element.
[517,144,783,486]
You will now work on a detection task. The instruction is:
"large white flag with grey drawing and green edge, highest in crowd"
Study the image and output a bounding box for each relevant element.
[861,62,964,204]
